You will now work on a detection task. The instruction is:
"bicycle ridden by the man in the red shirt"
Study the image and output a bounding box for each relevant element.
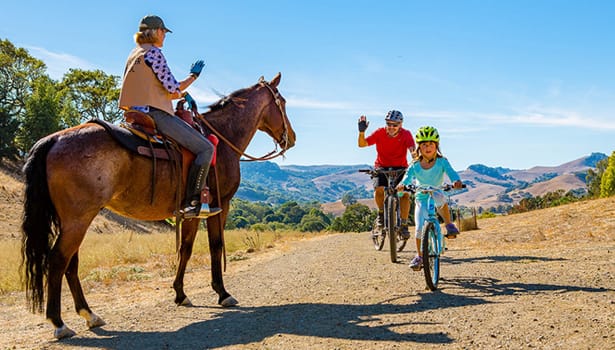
[359,168,408,262]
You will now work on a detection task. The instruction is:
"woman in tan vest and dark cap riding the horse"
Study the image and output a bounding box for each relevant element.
[119,16,220,218]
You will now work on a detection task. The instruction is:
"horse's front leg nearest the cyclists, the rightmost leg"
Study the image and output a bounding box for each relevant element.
[207,213,238,307]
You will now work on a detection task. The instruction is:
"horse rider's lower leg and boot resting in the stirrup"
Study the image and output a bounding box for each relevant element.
[182,162,222,219]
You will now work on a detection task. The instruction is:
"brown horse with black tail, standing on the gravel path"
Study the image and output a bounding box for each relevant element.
[22,73,295,338]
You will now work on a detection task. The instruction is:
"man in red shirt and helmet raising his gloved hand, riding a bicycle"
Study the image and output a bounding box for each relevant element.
[359,110,416,239]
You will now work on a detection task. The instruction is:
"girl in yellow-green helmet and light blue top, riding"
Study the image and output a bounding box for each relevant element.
[398,126,462,271]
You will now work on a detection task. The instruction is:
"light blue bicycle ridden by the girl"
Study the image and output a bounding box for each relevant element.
[406,184,466,291]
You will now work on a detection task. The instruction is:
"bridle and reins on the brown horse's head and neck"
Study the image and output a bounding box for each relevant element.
[194,77,289,162]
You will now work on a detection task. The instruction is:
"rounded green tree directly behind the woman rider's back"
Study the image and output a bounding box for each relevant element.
[60,68,122,126]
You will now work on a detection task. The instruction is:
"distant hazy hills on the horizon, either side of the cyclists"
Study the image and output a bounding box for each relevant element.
[236,153,607,208]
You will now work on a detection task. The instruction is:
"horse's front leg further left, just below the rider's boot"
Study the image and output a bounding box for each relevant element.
[173,219,201,306]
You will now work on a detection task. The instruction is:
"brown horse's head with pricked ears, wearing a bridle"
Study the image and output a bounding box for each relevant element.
[258,73,296,151]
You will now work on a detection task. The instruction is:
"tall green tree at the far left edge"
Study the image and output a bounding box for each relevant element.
[0,40,46,160]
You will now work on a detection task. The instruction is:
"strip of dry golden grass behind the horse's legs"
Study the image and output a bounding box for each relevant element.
[0,224,324,294]
